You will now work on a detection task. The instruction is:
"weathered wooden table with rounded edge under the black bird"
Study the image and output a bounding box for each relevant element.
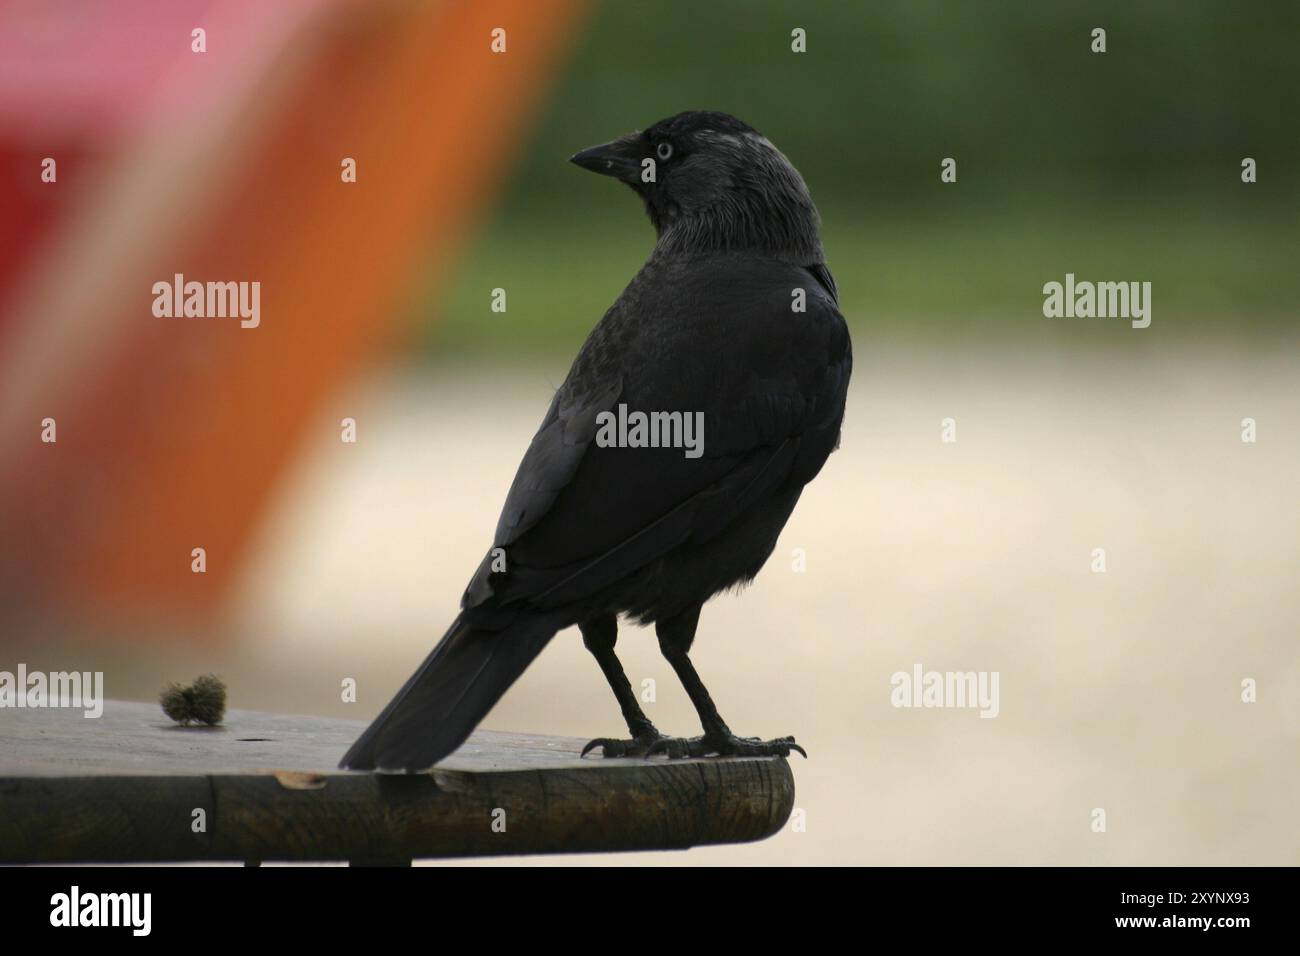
[0,701,794,865]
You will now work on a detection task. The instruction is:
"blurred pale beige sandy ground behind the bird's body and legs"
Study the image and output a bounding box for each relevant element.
[40,342,1300,865]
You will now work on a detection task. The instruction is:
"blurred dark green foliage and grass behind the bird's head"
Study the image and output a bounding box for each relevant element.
[419,0,1300,354]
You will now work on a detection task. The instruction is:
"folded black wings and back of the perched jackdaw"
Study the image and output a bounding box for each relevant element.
[464,258,852,610]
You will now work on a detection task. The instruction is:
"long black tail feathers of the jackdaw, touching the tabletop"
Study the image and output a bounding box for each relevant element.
[339,614,559,771]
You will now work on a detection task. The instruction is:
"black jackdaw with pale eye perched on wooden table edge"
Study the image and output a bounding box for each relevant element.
[341,112,852,771]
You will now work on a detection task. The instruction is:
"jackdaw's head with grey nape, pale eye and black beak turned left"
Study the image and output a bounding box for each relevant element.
[571,112,822,263]
